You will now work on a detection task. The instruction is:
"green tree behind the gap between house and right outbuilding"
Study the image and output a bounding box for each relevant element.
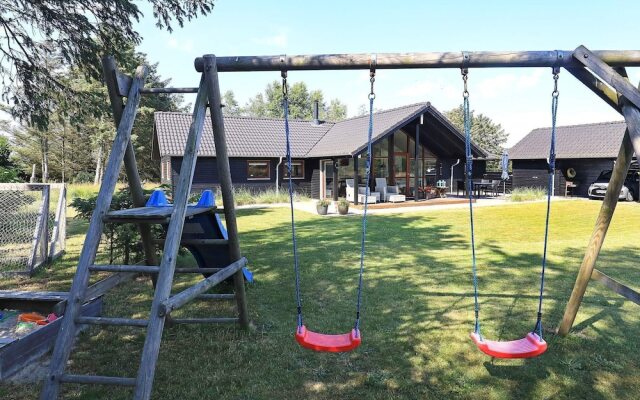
[445,104,509,159]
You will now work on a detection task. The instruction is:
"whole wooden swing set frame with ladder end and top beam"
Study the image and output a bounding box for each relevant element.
[41,46,640,400]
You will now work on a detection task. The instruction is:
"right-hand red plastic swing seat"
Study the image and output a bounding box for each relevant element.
[469,332,547,358]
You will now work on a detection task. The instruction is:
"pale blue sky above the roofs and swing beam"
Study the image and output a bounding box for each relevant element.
[132,0,640,145]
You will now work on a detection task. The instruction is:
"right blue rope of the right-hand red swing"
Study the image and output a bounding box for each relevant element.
[533,67,560,339]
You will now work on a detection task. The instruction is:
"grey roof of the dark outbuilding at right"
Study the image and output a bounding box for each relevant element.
[509,121,627,160]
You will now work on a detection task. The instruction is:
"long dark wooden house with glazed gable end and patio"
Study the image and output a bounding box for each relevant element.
[152,103,487,202]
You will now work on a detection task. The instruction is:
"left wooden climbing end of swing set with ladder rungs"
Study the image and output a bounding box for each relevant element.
[40,56,249,400]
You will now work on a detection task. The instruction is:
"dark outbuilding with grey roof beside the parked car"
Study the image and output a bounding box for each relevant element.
[509,121,627,197]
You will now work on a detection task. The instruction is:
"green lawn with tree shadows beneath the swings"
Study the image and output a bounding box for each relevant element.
[0,201,640,400]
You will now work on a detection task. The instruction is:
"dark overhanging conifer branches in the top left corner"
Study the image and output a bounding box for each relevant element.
[0,0,214,129]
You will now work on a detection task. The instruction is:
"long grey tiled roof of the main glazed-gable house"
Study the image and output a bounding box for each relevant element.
[154,103,487,158]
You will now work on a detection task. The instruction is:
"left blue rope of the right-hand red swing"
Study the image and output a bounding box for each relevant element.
[461,68,482,338]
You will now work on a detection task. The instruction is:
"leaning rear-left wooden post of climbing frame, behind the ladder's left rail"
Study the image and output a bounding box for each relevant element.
[102,56,158,276]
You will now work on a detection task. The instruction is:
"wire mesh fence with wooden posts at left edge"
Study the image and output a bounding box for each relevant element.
[0,183,66,274]
